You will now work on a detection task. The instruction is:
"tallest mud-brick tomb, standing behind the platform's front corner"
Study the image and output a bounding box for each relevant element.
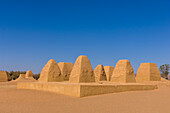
[69,56,95,83]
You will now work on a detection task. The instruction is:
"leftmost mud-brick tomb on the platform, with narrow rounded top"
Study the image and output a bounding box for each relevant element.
[38,59,63,82]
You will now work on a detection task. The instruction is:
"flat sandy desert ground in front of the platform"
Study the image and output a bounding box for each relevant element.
[0,83,170,113]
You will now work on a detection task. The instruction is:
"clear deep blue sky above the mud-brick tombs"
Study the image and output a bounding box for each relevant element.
[0,0,170,73]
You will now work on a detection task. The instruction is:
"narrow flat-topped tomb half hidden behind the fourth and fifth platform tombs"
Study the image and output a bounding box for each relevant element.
[104,66,114,81]
